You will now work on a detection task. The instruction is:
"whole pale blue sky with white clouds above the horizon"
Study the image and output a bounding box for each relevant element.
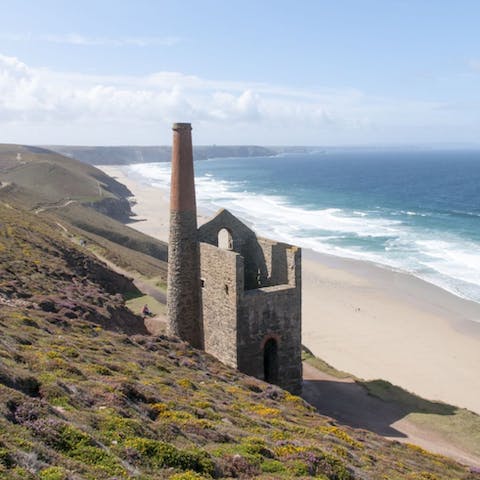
[0,0,480,145]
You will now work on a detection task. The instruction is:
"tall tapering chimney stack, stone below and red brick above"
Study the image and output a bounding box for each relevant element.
[167,123,203,348]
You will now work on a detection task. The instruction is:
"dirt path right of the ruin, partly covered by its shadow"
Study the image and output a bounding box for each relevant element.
[302,363,480,467]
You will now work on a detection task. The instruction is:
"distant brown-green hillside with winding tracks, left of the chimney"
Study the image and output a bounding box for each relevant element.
[0,145,167,282]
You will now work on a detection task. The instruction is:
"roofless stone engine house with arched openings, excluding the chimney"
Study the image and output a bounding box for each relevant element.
[199,210,302,393]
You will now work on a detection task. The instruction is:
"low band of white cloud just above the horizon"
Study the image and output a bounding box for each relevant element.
[0,55,480,145]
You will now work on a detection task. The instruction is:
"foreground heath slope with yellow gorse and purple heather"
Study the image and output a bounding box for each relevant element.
[0,197,480,480]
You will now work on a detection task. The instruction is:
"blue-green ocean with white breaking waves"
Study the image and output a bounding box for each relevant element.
[127,149,480,302]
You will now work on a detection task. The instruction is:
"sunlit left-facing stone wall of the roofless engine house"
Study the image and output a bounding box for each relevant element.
[200,243,243,368]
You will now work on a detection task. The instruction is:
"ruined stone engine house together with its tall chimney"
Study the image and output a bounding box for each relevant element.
[167,123,302,393]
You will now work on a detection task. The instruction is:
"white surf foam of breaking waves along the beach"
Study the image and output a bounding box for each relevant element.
[129,163,480,302]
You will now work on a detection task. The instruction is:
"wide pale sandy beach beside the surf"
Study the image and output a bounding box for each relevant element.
[100,166,480,414]
